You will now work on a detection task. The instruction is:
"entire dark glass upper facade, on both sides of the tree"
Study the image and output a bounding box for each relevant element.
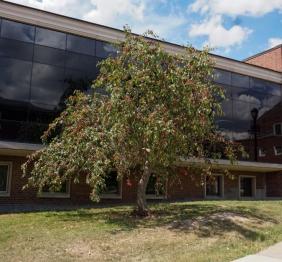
[0,18,282,162]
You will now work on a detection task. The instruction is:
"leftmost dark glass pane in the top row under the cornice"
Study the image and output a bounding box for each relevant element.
[1,19,34,42]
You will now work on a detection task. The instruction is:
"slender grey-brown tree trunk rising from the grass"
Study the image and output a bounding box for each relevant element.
[136,162,151,217]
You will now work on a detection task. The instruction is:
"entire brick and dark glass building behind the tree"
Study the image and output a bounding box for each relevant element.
[0,2,282,204]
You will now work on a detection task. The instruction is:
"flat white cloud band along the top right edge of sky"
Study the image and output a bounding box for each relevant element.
[188,0,282,16]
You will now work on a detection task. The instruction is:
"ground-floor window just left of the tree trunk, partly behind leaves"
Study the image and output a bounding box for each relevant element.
[101,171,121,198]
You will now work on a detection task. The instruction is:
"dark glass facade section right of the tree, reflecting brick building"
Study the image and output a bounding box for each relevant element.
[215,69,282,163]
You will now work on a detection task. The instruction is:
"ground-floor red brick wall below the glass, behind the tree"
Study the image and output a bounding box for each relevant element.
[0,156,282,204]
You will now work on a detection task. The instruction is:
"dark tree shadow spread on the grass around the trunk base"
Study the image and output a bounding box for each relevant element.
[46,202,278,241]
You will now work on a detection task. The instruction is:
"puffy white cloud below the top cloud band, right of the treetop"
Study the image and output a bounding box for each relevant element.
[189,15,252,49]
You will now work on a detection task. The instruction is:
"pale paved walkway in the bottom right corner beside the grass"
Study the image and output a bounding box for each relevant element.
[234,242,282,262]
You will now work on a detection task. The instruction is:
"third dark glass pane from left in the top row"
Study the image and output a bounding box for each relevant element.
[67,35,95,55]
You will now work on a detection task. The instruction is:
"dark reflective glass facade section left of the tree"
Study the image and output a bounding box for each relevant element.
[0,18,116,143]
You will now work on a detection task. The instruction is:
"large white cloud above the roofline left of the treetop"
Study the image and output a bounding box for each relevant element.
[4,0,186,38]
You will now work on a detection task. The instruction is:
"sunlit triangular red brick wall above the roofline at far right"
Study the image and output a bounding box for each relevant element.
[246,46,282,72]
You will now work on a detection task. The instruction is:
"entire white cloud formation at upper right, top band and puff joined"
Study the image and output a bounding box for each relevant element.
[188,0,282,51]
